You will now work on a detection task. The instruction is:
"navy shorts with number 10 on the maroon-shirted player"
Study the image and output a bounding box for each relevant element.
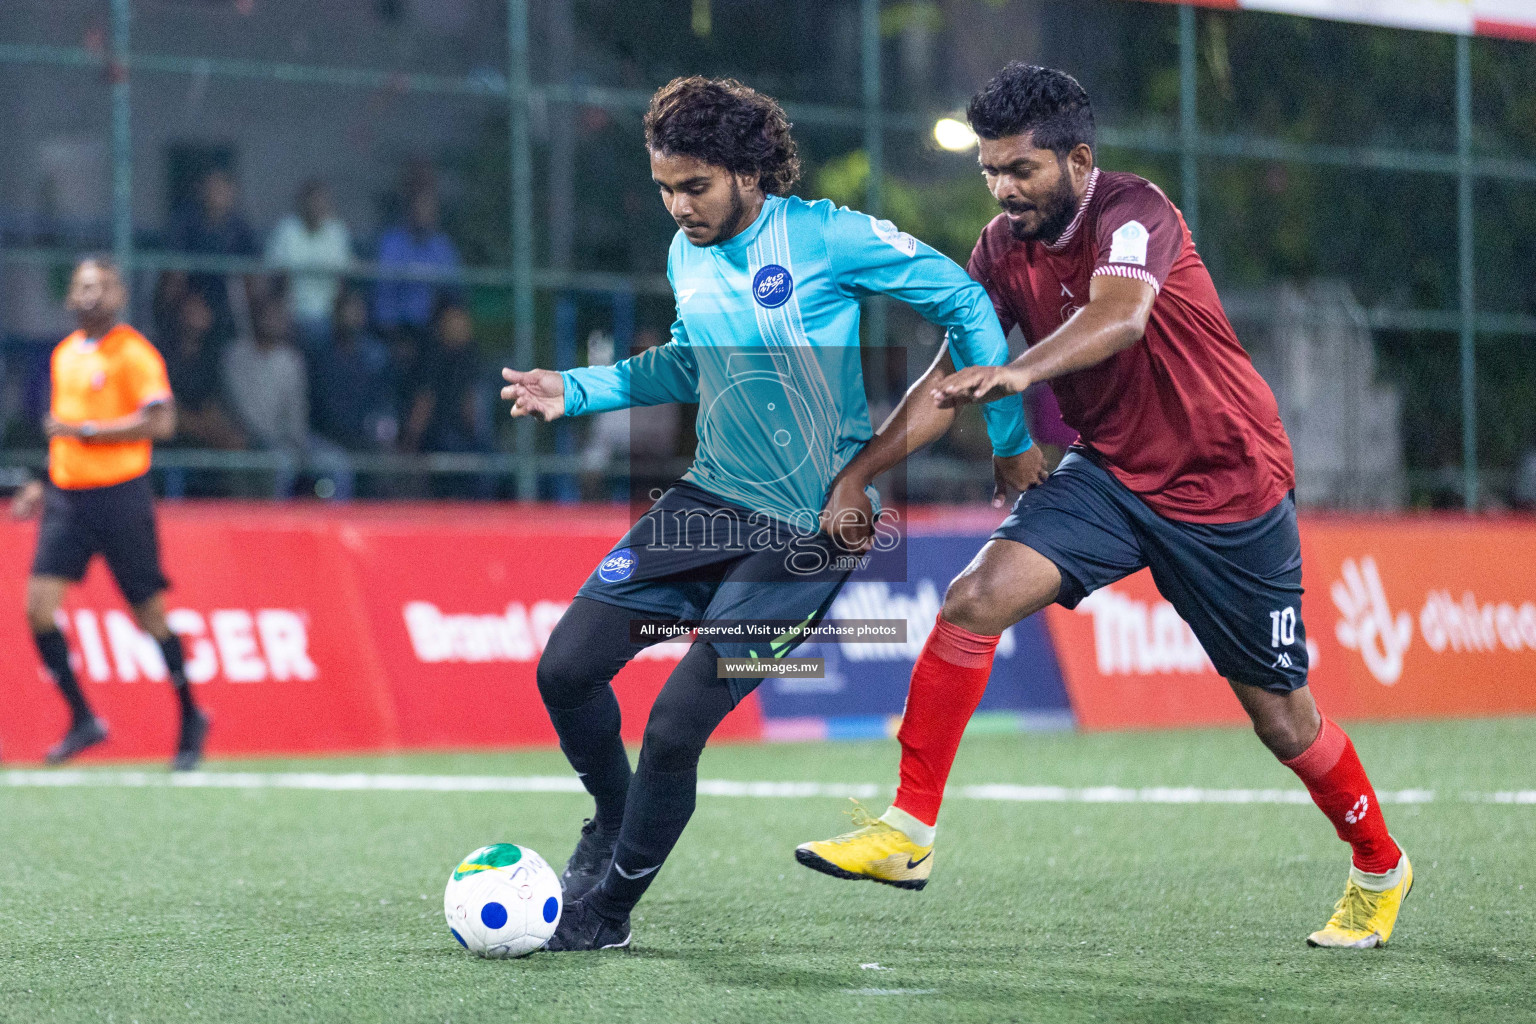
[992,451,1307,692]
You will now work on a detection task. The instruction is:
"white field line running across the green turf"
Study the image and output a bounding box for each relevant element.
[0,769,1536,804]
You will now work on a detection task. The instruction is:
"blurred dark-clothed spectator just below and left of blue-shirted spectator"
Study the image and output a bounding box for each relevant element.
[310,286,399,451]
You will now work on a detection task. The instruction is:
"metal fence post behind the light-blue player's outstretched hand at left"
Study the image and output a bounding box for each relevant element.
[507,0,539,499]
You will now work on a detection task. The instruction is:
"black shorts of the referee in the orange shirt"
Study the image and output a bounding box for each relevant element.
[32,473,170,605]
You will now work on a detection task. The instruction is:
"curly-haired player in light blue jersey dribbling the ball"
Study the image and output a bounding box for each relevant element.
[502,78,1044,950]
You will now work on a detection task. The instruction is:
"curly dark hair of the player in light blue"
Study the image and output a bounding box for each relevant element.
[645,75,800,195]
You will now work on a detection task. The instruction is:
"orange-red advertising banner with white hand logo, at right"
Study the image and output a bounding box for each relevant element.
[1046,516,1536,729]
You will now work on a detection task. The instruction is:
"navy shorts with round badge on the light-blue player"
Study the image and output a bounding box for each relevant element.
[576,481,860,702]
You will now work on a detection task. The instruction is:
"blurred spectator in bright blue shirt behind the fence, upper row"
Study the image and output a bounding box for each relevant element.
[373,175,459,386]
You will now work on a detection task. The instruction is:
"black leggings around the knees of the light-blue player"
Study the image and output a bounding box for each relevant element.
[538,597,736,772]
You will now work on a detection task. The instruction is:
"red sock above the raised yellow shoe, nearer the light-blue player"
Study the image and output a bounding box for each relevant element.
[895,616,1000,824]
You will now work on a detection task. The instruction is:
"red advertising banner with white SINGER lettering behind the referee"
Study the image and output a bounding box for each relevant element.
[0,502,760,763]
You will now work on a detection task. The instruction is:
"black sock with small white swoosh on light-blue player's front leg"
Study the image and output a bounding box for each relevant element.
[587,760,699,920]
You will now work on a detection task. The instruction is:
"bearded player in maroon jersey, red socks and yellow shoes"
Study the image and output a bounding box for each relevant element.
[796,63,1413,949]
